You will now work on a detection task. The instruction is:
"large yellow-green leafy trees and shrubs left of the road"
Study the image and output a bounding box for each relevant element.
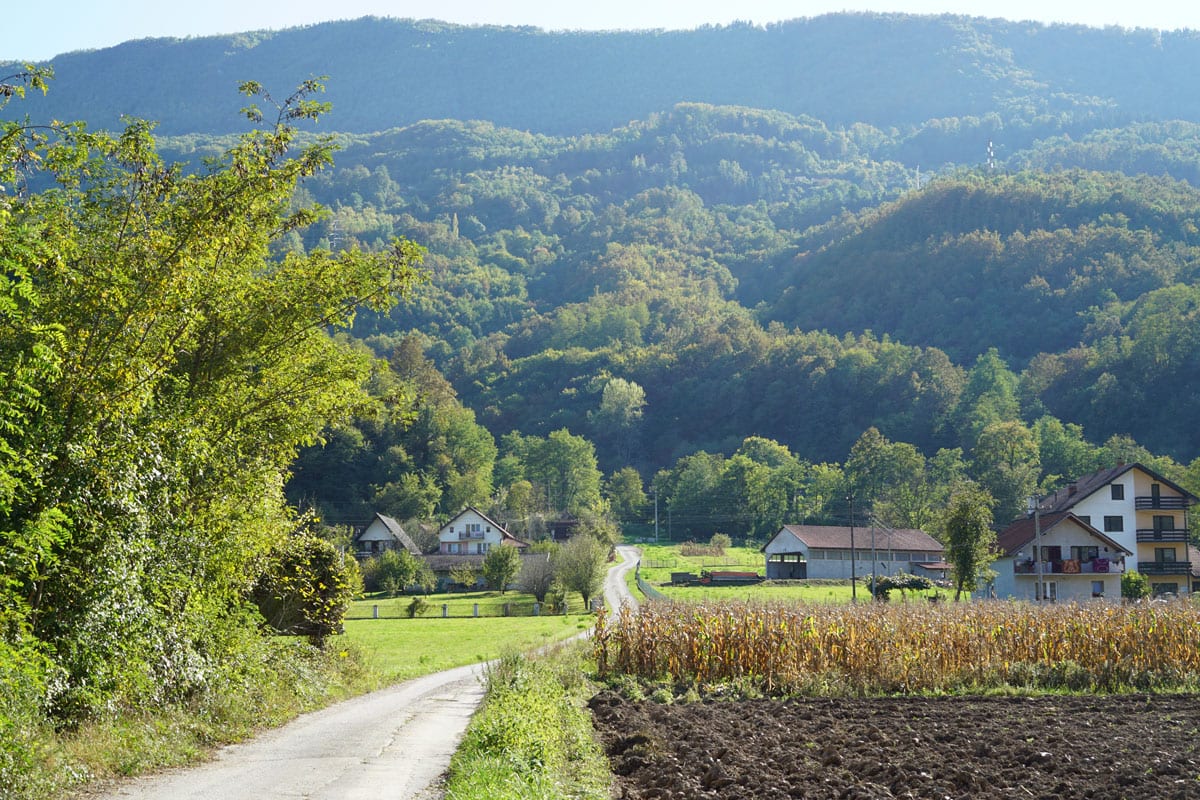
[0,79,421,724]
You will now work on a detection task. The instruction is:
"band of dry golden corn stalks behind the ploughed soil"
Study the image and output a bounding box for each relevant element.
[594,601,1200,694]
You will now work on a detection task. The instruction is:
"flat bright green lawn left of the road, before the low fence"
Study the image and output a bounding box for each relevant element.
[341,614,595,682]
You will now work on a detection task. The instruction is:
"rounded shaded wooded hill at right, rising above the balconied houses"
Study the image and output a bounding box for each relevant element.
[745,170,1200,362]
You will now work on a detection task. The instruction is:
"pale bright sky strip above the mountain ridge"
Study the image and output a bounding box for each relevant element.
[0,0,1200,62]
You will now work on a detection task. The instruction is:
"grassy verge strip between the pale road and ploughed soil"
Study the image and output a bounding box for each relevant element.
[445,643,611,800]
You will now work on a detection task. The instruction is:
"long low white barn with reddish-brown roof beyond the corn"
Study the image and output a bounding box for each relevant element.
[762,525,946,581]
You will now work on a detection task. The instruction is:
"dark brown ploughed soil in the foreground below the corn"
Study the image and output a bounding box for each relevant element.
[592,692,1200,800]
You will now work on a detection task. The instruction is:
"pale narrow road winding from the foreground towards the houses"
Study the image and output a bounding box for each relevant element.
[85,547,637,800]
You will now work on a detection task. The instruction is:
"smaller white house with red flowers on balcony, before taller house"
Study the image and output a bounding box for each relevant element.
[990,511,1133,601]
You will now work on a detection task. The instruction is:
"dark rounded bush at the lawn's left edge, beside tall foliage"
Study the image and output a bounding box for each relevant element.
[251,534,361,644]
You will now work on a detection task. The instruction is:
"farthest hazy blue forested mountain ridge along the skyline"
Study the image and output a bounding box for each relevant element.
[7,13,1200,134]
